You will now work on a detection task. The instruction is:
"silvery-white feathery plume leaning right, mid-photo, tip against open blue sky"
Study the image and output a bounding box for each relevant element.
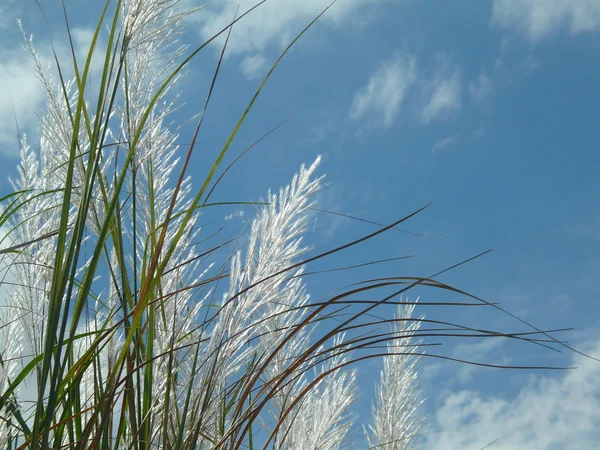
[199,157,322,442]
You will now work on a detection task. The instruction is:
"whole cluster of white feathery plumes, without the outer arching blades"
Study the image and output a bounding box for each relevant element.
[0,0,420,450]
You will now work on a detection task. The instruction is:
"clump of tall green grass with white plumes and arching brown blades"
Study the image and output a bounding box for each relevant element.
[0,0,580,450]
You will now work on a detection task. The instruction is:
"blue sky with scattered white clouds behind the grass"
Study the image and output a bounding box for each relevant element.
[0,0,600,450]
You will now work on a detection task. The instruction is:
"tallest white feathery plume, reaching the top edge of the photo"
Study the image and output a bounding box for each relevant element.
[120,0,213,445]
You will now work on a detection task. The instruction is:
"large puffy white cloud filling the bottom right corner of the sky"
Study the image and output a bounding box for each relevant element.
[426,340,600,450]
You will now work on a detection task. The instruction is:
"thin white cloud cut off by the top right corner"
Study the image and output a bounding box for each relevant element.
[491,0,600,43]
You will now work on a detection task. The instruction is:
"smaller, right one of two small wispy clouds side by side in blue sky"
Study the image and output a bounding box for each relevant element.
[420,53,462,123]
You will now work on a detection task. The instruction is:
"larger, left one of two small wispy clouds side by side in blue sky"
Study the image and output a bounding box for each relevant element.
[350,54,417,128]
